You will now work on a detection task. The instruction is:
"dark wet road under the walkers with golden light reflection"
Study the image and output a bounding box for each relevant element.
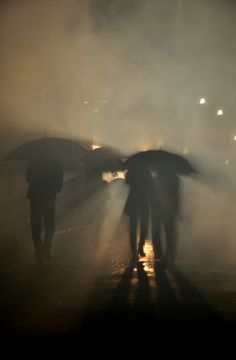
[0,234,236,339]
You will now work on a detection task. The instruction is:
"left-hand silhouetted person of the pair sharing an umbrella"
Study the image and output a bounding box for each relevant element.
[124,162,152,260]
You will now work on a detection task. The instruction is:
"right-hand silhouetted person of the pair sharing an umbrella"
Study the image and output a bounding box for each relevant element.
[151,168,179,265]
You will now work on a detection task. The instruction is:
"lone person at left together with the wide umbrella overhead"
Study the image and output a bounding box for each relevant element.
[4,136,88,263]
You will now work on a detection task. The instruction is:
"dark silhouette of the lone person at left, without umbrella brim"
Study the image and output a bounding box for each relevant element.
[26,146,63,264]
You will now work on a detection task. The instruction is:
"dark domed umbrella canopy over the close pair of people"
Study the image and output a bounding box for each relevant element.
[125,150,196,175]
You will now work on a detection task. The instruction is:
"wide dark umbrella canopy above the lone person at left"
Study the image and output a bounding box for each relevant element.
[4,137,87,170]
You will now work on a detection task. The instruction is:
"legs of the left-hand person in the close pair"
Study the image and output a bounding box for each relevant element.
[129,205,149,257]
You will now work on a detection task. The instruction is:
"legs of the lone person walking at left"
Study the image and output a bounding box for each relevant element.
[30,196,56,263]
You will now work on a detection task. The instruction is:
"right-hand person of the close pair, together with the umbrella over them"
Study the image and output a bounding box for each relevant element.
[127,150,196,266]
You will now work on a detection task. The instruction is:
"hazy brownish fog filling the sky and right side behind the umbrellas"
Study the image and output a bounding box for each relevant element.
[0,0,236,268]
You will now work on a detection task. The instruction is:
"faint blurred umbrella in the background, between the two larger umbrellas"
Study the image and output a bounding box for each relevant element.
[82,146,124,174]
